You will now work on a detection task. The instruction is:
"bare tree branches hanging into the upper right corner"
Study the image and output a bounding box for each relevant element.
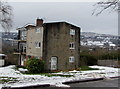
[92,0,120,16]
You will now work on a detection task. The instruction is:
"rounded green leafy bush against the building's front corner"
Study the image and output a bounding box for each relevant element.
[26,58,44,73]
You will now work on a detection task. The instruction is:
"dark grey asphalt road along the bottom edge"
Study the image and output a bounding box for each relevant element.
[9,79,120,89]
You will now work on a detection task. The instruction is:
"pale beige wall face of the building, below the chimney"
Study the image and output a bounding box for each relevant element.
[26,27,43,58]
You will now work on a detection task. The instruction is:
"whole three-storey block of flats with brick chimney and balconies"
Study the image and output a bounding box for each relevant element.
[17,19,80,70]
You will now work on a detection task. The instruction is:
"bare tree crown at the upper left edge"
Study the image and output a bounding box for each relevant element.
[0,0,13,32]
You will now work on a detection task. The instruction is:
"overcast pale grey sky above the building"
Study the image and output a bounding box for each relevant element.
[5,2,118,35]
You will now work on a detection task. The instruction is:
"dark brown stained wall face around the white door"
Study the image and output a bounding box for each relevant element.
[43,22,80,70]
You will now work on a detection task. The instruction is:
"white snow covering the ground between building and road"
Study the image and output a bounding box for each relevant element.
[0,65,119,89]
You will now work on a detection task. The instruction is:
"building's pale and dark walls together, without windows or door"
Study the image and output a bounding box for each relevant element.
[19,21,80,70]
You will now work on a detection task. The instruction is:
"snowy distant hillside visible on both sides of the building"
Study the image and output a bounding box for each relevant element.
[0,32,120,48]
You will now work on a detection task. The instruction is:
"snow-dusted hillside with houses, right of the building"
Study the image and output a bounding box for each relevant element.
[81,32,120,48]
